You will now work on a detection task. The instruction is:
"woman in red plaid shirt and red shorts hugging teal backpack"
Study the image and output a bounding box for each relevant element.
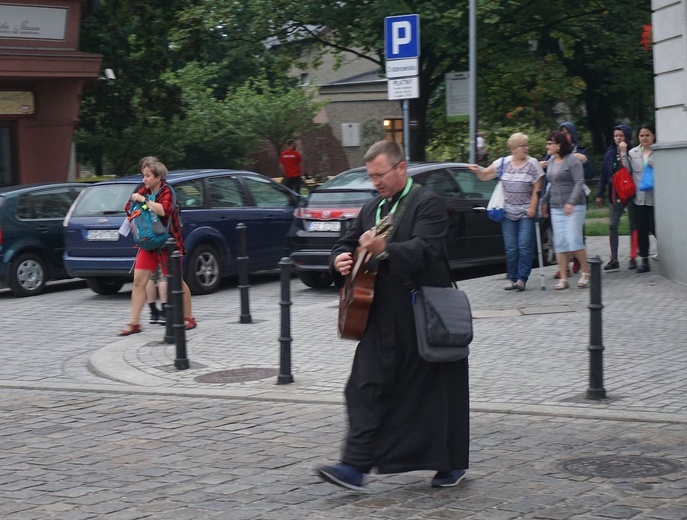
[119,157,197,336]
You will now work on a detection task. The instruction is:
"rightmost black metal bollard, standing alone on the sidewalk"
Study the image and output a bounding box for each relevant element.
[586,256,606,399]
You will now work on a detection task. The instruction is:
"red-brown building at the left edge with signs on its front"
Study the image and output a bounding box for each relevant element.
[0,0,102,186]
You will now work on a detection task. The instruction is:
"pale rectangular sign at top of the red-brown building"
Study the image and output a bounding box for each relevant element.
[0,4,69,40]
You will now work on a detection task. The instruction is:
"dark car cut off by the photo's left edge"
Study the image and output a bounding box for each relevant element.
[0,182,87,296]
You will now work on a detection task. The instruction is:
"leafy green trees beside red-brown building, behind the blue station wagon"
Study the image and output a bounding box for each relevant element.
[76,0,309,175]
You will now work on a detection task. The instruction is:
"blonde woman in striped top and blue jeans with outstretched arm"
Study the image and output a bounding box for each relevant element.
[470,132,544,291]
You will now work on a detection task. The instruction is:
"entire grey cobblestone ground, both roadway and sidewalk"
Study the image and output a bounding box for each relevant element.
[0,238,687,520]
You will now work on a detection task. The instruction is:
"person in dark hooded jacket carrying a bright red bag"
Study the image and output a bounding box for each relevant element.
[596,125,636,271]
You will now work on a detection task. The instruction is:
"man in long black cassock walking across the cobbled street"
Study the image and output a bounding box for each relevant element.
[317,141,470,490]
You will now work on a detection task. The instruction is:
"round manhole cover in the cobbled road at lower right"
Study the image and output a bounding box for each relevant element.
[562,455,682,478]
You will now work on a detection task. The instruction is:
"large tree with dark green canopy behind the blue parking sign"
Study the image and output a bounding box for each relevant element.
[180,0,652,158]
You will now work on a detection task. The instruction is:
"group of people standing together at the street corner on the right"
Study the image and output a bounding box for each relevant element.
[470,122,656,291]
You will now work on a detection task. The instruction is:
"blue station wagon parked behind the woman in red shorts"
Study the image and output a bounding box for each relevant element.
[64,170,299,294]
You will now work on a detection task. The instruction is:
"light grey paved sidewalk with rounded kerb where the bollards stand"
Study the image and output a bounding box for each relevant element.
[90,237,687,424]
